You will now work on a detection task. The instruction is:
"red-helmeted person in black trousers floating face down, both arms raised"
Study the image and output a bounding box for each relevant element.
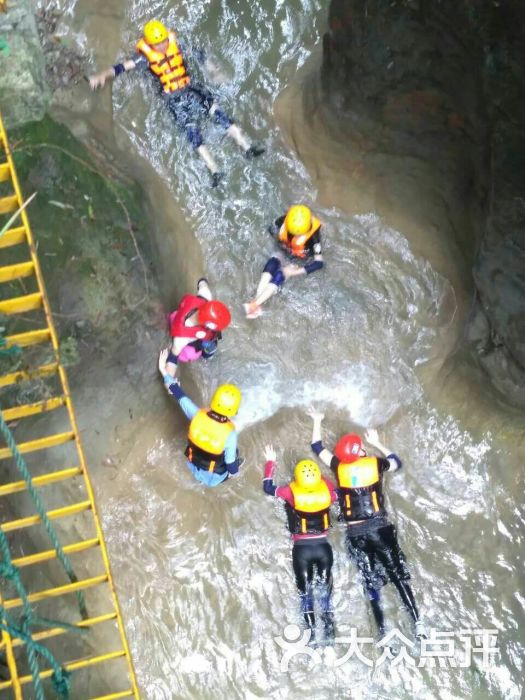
[312,413,425,637]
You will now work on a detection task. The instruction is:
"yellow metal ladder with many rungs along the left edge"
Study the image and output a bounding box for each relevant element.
[0,109,139,700]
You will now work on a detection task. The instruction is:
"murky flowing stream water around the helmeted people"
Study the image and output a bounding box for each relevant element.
[42,0,525,700]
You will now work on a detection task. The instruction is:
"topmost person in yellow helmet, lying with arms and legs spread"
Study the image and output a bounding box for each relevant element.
[89,20,265,187]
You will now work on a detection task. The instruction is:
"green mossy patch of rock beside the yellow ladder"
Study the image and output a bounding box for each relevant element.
[9,117,156,360]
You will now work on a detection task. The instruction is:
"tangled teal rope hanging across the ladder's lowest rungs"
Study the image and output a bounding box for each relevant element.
[0,529,71,700]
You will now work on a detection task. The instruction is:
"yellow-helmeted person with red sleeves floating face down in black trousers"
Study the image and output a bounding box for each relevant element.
[263,445,337,643]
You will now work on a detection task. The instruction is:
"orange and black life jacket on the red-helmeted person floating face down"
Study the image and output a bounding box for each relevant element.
[337,457,385,522]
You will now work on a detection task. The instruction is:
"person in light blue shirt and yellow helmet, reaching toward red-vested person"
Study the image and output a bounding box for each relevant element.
[159,350,244,486]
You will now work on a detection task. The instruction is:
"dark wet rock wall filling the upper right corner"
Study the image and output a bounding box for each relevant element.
[310,0,525,404]
